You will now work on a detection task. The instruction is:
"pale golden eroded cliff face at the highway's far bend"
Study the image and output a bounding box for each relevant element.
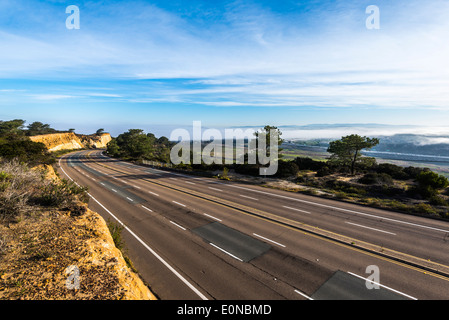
[30,132,111,152]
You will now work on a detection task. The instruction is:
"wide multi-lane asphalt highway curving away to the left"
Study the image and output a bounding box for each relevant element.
[59,150,449,300]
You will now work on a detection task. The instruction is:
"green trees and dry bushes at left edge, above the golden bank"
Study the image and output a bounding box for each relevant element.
[0,120,88,222]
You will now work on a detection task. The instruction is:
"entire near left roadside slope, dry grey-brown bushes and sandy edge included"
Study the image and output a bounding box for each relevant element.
[0,161,155,300]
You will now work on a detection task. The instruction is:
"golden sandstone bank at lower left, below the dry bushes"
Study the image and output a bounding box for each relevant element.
[0,166,157,300]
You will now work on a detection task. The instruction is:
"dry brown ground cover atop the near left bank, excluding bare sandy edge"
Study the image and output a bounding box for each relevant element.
[0,212,124,300]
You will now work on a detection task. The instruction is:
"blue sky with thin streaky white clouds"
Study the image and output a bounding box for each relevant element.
[0,0,449,135]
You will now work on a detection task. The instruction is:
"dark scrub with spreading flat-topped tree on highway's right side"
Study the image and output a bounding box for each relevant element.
[279,135,449,219]
